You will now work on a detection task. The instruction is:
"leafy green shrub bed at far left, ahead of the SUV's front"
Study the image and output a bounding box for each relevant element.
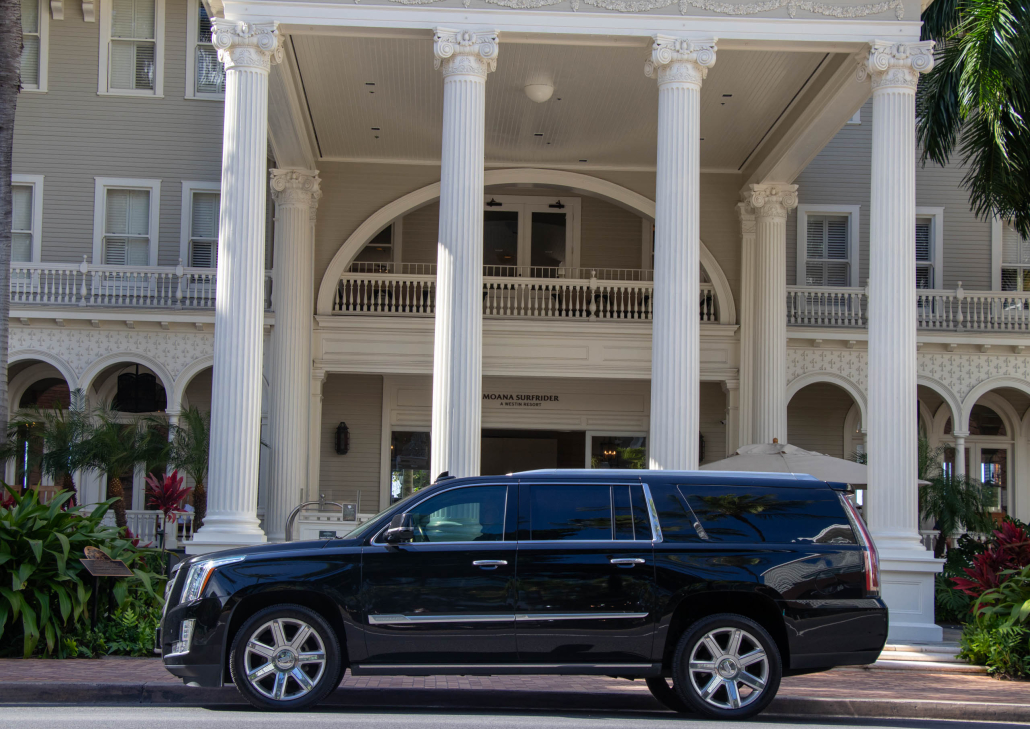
[0,484,164,657]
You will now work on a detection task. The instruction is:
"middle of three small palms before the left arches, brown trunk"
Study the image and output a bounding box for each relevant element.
[80,410,168,527]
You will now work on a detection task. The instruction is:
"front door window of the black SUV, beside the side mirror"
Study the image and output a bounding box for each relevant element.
[408,486,508,543]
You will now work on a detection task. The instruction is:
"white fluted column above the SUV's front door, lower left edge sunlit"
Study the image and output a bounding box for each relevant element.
[430,28,497,478]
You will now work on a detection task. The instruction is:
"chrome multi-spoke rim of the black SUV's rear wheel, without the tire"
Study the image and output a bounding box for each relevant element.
[688,628,769,708]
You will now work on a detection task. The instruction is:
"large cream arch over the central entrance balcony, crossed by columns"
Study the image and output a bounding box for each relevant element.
[315,169,736,324]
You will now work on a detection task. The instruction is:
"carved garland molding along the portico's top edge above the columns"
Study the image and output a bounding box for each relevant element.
[385,0,904,21]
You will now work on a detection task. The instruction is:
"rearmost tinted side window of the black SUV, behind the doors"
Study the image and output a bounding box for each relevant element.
[680,486,856,545]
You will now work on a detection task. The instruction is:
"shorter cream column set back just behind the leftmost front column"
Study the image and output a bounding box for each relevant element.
[265,170,321,542]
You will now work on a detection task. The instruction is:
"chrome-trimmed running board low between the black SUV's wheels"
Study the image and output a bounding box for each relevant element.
[350,663,661,679]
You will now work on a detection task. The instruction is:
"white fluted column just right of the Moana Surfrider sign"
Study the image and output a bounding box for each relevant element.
[644,35,716,470]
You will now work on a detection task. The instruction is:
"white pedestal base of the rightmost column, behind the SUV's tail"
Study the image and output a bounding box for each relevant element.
[878,542,945,643]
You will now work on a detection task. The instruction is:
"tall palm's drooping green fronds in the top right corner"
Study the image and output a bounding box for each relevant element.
[917,0,1030,237]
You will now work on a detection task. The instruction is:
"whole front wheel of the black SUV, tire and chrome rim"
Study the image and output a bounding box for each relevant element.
[229,604,342,711]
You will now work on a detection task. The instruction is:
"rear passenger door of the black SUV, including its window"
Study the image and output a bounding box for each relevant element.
[515,482,657,664]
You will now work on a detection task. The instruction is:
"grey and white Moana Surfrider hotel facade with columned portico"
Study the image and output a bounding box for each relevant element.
[8,0,1030,639]
